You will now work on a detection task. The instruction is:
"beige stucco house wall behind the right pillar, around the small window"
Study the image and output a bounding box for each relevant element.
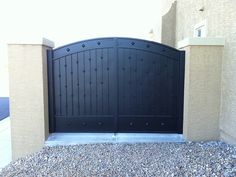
[172,0,236,143]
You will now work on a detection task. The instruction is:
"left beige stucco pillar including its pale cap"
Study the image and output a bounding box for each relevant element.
[8,39,54,160]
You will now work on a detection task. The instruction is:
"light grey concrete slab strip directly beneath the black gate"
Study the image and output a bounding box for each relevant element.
[45,133,184,146]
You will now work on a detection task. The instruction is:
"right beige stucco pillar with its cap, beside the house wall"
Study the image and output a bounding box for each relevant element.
[178,38,224,141]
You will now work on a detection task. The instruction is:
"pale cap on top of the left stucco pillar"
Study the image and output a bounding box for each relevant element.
[7,38,55,48]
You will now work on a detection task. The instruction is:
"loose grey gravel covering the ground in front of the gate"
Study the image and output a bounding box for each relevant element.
[0,141,236,177]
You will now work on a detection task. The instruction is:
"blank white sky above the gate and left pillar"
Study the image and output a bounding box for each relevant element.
[0,0,162,96]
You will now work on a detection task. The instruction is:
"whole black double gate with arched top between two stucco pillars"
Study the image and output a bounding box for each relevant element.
[48,38,184,133]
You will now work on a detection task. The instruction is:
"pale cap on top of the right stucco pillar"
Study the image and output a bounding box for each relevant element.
[177,37,225,49]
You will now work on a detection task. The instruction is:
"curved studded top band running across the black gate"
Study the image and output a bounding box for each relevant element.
[53,37,180,59]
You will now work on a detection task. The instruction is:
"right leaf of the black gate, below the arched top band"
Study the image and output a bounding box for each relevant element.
[118,48,179,132]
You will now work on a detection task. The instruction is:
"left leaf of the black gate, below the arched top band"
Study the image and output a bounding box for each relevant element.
[49,45,116,132]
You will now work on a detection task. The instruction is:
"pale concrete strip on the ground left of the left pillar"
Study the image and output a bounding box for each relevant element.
[0,117,12,169]
